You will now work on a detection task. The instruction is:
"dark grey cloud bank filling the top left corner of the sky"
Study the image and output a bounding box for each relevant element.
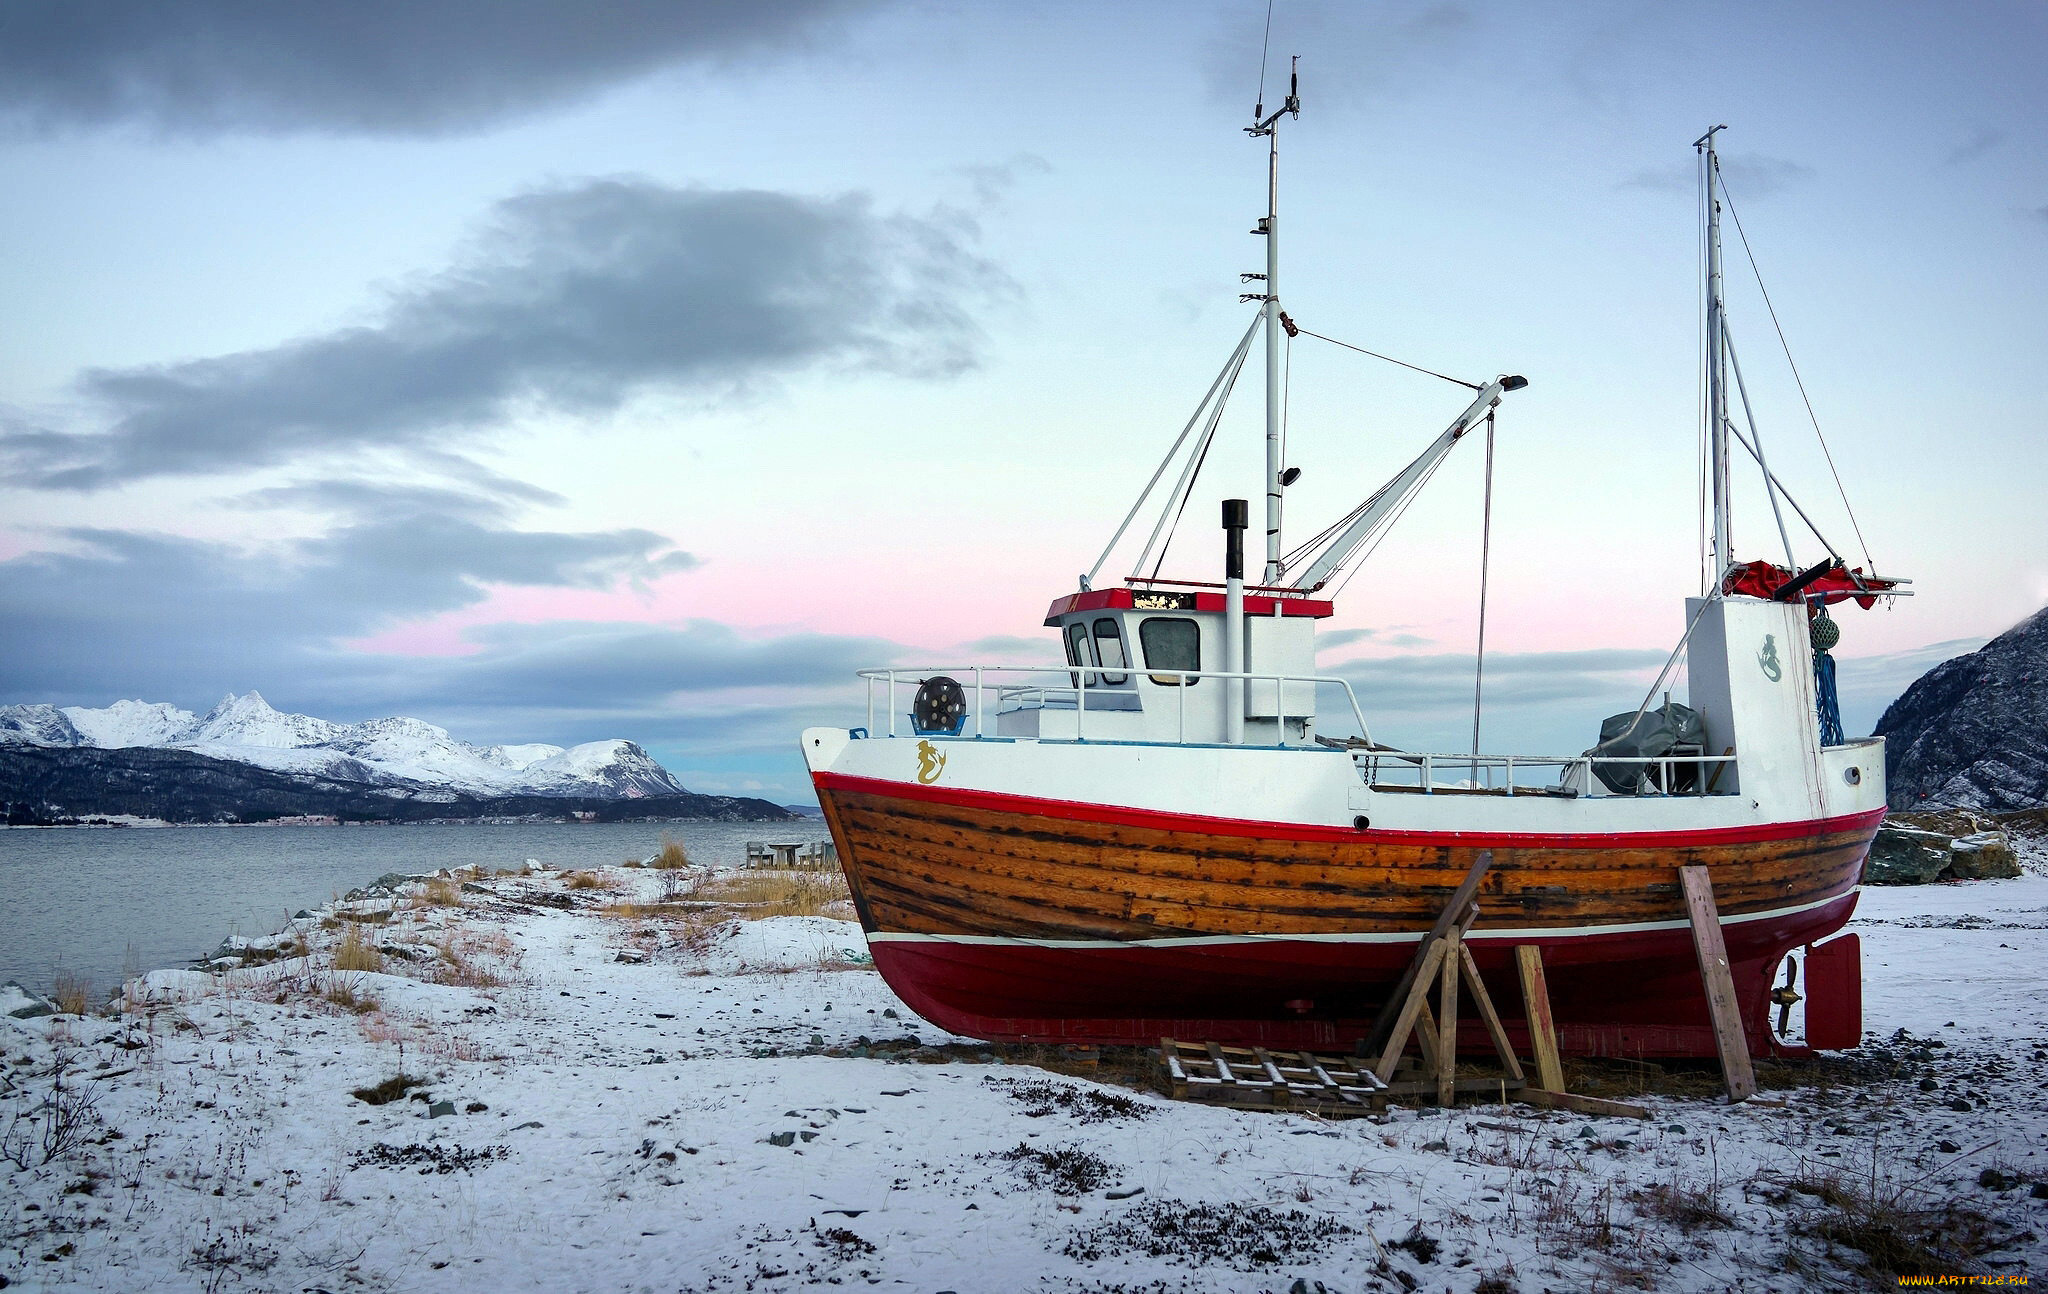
[0,0,872,135]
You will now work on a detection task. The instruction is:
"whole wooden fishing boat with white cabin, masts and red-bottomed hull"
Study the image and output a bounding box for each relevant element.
[803,92,1903,1056]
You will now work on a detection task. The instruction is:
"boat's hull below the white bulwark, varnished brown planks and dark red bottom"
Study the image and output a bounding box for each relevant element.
[815,772,1882,1056]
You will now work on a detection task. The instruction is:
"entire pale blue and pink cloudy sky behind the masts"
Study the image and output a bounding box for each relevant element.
[0,0,2048,803]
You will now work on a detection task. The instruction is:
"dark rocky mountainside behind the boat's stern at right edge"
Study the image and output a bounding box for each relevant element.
[1878,610,2048,811]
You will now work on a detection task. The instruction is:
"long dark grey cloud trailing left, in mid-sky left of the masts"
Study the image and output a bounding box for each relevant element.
[0,180,1006,489]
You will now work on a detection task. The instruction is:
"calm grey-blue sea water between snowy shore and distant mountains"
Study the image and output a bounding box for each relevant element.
[0,819,827,995]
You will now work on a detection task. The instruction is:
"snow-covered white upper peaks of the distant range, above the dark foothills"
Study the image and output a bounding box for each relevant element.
[0,692,684,796]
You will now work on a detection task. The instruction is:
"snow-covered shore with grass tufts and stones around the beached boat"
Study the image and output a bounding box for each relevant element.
[0,868,2048,1294]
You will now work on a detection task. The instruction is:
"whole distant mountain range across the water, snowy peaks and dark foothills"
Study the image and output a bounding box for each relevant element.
[0,692,788,821]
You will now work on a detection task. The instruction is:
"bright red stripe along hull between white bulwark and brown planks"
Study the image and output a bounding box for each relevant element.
[811,769,1884,850]
